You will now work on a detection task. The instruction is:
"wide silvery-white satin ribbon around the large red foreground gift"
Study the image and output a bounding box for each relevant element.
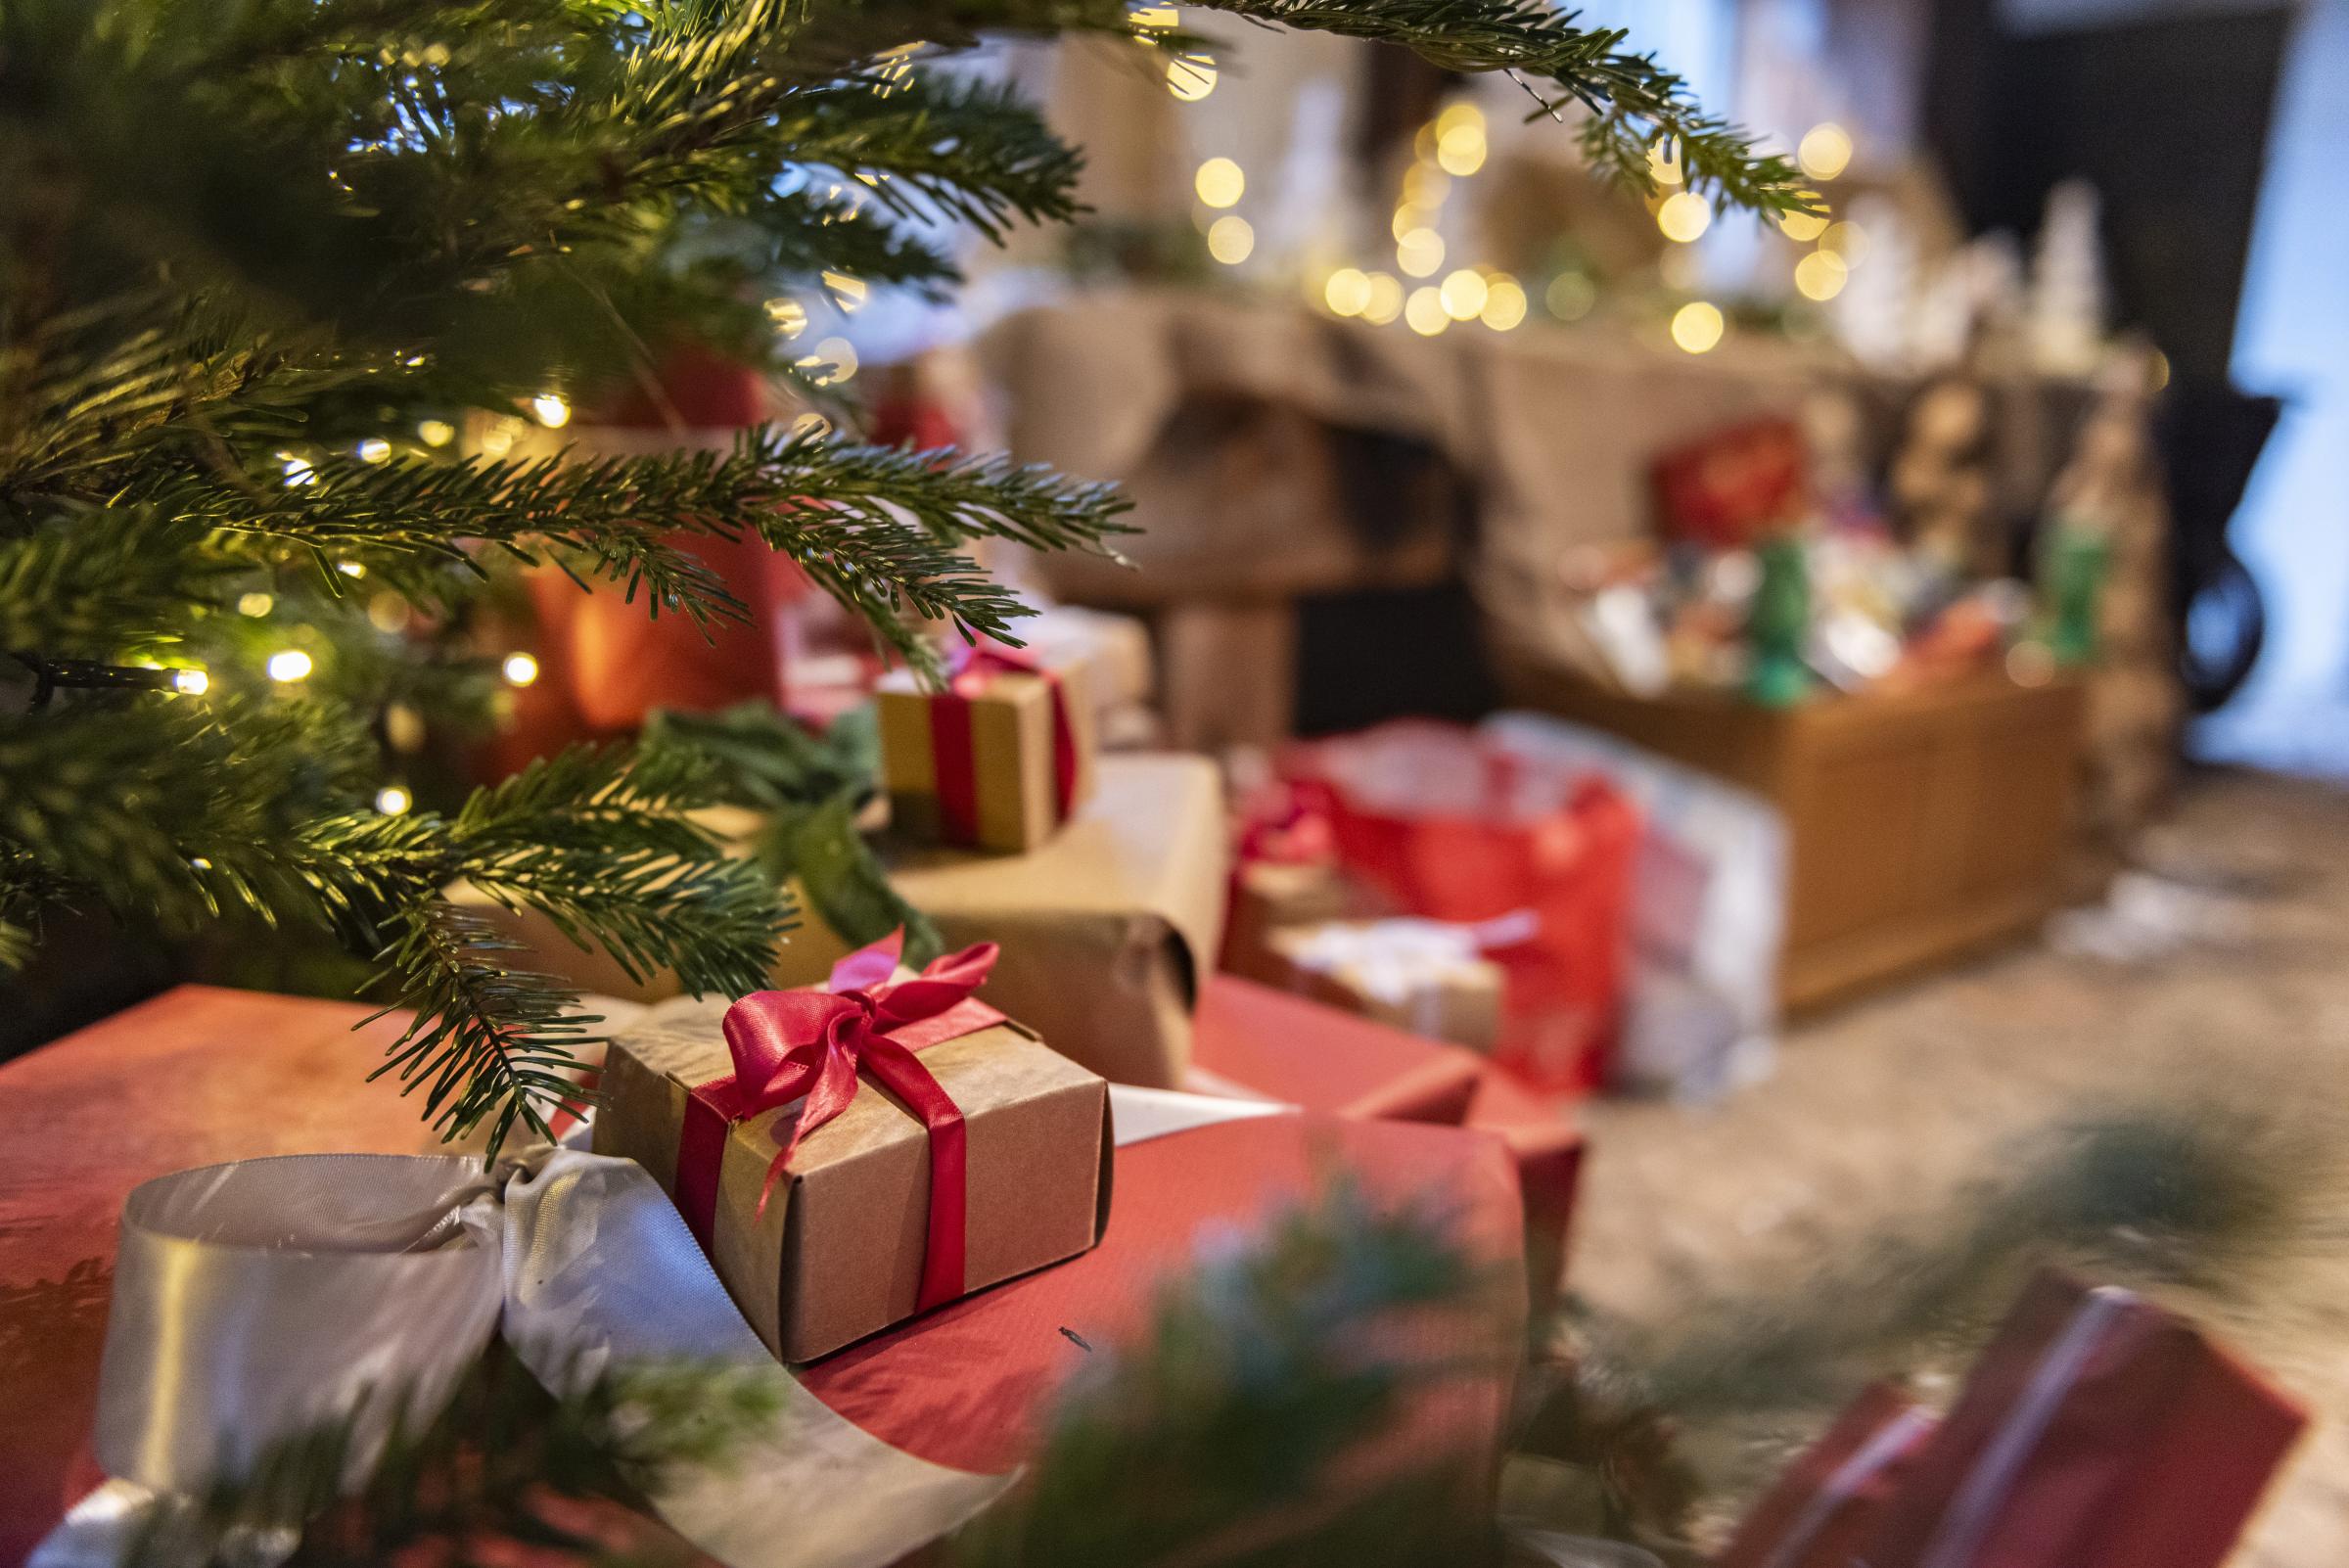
[30,1084,1280,1568]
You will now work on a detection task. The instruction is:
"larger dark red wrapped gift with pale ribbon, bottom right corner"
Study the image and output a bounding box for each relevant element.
[1861,1269,2307,1568]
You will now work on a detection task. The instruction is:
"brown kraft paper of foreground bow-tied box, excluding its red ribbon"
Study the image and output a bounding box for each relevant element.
[594,986,1111,1361]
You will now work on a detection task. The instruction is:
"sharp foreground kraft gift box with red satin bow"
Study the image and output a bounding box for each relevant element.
[594,937,1111,1361]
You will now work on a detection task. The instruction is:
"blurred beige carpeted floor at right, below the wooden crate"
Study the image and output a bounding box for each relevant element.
[1572,774,2349,1568]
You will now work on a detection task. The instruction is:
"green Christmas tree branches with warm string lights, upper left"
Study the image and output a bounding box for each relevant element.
[0,0,1811,1143]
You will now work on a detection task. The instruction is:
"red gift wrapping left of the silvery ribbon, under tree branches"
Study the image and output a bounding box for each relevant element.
[0,986,433,1563]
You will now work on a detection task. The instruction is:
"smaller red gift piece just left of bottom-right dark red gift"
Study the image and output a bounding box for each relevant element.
[1713,1383,1936,1568]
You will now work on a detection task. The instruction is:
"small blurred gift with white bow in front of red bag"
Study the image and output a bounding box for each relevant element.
[1268,920,1505,1051]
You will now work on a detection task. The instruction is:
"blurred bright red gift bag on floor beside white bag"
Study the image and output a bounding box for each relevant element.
[1282,720,1639,1089]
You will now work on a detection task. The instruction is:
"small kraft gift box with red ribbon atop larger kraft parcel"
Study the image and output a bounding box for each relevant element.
[874,643,1094,854]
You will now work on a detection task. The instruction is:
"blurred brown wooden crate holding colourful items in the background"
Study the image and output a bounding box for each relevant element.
[1515,673,2084,1009]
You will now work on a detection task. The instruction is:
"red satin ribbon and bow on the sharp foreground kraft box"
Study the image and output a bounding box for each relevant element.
[676,930,1003,1310]
